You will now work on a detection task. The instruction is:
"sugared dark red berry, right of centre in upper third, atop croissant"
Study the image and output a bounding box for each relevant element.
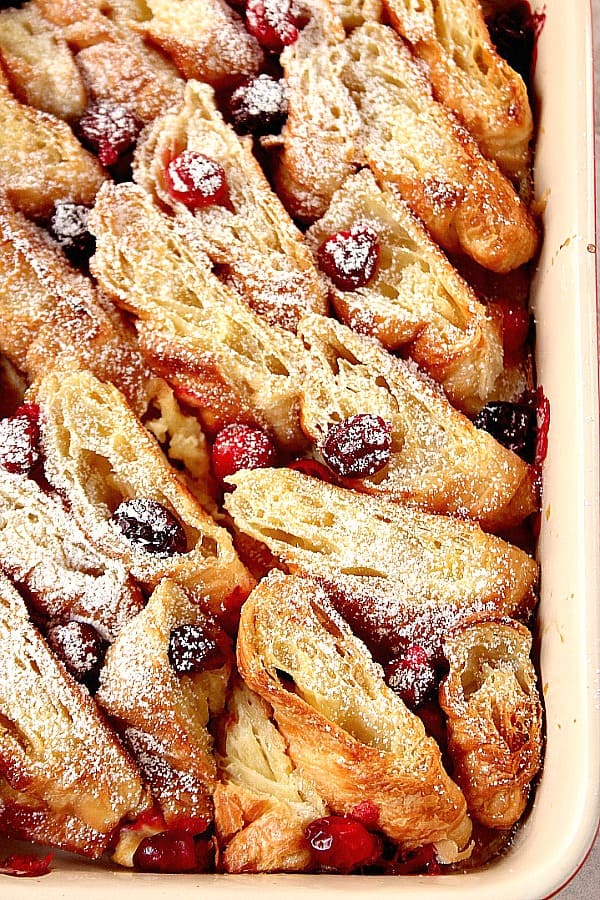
[317,222,379,291]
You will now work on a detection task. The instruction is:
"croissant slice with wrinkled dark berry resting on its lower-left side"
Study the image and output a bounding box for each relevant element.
[299,316,536,530]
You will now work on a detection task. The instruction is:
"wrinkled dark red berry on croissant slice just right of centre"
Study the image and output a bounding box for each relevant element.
[321,413,392,478]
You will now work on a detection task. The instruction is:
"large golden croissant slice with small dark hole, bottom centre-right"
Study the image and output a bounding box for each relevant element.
[237,572,471,852]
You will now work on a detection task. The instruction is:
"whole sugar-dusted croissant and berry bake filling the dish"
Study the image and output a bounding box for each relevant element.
[0,0,548,890]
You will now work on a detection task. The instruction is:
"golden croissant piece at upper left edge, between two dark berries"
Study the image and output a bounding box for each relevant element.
[0,83,107,219]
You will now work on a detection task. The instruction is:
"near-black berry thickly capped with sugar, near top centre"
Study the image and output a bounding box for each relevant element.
[229,74,287,135]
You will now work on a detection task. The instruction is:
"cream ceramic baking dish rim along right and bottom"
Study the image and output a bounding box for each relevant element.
[0,0,600,900]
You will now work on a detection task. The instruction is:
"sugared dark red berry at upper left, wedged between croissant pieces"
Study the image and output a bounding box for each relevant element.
[79,100,141,166]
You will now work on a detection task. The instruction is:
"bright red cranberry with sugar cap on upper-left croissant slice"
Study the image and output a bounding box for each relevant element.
[165,150,231,209]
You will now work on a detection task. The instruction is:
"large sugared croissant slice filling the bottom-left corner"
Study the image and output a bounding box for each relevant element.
[0,575,147,858]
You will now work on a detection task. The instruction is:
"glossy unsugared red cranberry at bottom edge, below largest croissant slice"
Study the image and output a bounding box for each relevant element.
[304,816,382,873]
